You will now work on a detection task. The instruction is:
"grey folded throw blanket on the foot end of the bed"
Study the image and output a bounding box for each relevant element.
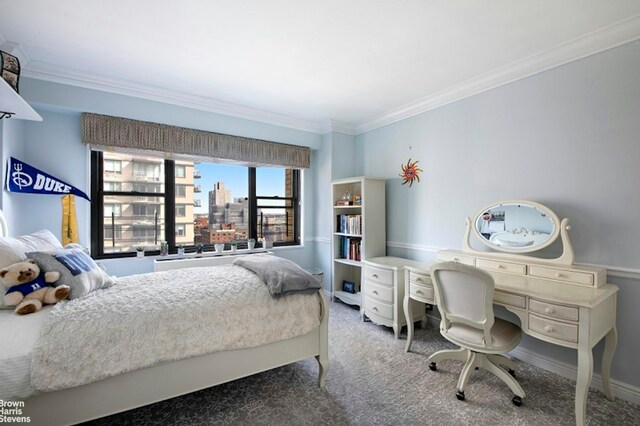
[233,254,321,297]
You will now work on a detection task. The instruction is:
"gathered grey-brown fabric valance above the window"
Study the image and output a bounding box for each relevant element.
[82,113,311,169]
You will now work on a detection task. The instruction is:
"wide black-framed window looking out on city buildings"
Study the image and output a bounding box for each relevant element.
[91,152,300,258]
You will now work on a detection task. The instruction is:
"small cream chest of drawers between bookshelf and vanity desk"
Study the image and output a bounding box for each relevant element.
[360,257,433,339]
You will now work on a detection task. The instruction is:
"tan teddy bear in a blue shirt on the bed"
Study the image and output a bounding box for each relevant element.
[0,259,71,315]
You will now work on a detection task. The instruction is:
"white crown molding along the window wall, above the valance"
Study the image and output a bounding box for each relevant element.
[22,61,322,134]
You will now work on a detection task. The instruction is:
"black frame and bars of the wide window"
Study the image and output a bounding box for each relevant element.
[91,151,302,259]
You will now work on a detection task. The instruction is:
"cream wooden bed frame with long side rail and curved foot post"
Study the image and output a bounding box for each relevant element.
[0,211,329,426]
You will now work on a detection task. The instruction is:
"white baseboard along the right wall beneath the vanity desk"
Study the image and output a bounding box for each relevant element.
[427,314,640,404]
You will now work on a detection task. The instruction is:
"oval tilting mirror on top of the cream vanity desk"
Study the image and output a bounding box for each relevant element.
[474,200,560,253]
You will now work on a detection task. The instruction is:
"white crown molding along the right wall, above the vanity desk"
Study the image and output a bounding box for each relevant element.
[356,14,640,134]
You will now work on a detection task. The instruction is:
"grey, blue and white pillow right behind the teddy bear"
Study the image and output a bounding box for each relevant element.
[27,248,114,299]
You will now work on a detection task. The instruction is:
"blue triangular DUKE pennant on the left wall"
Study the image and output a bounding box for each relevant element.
[6,157,91,202]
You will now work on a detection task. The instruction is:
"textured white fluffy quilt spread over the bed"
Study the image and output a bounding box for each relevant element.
[31,265,320,391]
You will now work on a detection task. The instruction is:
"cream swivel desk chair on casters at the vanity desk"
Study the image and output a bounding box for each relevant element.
[429,262,525,406]
